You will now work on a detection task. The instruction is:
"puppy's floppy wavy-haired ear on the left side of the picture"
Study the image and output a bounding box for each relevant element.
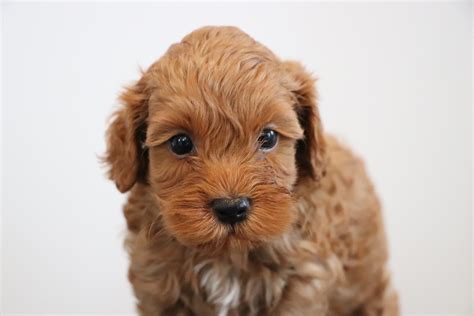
[104,78,149,193]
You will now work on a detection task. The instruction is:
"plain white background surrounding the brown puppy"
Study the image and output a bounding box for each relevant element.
[1,1,472,315]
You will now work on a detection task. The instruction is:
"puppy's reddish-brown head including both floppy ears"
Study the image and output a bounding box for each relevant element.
[106,27,324,250]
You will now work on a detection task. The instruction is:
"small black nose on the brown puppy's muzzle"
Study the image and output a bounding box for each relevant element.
[211,197,250,225]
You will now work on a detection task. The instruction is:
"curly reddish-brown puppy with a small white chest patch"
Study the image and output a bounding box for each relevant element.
[104,27,398,315]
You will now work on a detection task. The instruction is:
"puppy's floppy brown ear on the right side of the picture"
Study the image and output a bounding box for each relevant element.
[282,61,326,180]
